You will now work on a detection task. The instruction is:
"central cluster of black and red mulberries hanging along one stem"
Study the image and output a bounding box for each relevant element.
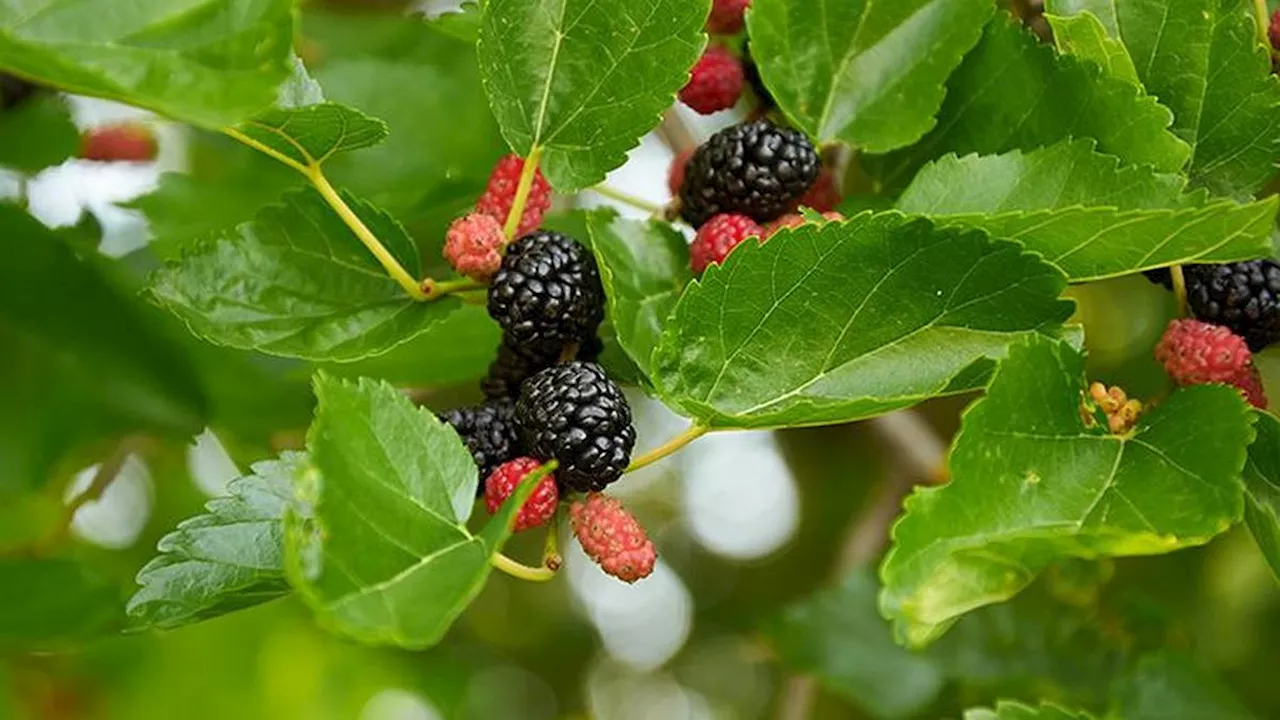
[443,155,655,582]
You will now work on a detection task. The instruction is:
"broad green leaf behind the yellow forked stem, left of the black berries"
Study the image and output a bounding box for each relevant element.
[151,190,458,361]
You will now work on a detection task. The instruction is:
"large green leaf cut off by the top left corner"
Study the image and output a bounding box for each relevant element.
[0,0,293,128]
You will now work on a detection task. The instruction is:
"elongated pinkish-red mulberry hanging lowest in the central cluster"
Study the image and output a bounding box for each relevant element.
[568,492,658,583]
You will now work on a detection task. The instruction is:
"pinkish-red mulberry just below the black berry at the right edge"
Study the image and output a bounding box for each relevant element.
[1156,320,1252,386]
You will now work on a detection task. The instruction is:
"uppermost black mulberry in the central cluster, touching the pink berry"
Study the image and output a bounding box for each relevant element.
[489,231,604,355]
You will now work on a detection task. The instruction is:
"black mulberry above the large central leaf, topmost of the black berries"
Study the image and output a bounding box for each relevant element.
[680,120,820,227]
